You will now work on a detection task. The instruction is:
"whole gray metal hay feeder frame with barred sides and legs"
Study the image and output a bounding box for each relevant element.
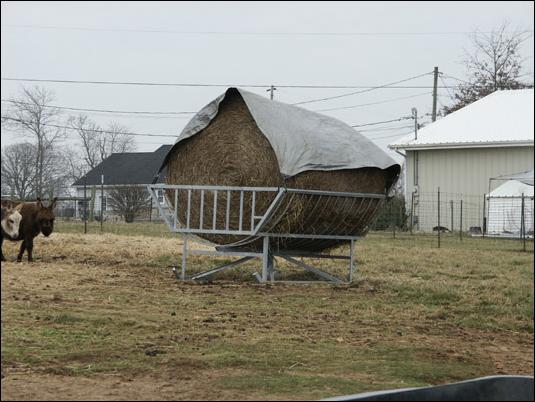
[147,184,386,284]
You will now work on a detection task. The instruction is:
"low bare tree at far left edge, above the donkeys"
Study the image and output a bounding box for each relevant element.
[2,142,37,200]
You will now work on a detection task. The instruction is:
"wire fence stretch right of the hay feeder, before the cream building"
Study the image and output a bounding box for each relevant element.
[370,191,534,251]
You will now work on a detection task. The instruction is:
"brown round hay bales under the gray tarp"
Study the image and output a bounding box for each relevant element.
[166,91,399,249]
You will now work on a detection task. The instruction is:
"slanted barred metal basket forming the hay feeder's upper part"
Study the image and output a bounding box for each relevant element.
[148,184,385,240]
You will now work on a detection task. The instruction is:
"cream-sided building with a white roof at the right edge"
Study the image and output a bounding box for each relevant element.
[389,89,534,231]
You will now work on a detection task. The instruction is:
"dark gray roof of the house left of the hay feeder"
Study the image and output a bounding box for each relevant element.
[73,145,171,186]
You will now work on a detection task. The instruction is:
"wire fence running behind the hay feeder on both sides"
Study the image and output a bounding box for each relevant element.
[2,188,534,251]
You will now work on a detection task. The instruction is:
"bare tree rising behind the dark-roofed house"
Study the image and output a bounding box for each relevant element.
[68,114,136,170]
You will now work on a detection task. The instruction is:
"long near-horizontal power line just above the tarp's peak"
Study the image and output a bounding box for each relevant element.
[1,77,456,89]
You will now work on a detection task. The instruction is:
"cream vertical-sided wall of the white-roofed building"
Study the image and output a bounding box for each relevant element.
[405,146,534,231]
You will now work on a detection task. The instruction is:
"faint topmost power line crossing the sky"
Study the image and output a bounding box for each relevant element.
[2,24,533,36]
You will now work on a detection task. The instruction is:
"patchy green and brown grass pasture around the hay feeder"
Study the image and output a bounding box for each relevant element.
[2,222,534,400]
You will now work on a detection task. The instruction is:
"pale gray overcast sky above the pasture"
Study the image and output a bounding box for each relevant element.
[1,1,534,162]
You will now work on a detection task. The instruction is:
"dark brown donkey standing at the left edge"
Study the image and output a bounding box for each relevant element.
[0,198,57,262]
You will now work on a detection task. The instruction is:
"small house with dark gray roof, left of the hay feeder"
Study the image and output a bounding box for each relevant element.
[72,145,171,218]
